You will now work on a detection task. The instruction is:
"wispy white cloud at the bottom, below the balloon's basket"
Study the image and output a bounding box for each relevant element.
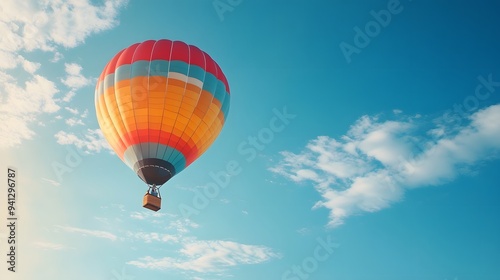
[124,212,281,274]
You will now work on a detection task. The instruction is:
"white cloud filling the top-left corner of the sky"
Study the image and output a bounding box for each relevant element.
[0,0,126,51]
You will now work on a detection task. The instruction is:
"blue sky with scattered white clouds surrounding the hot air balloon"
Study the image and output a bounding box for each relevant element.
[0,0,500,280]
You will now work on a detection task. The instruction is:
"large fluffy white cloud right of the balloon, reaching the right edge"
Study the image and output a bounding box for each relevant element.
[270,105,500,226]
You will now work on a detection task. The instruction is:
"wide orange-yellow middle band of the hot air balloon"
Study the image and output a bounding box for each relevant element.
[98,77,224,161]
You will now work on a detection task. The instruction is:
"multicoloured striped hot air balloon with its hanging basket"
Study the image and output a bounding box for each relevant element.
[95,39,230,211]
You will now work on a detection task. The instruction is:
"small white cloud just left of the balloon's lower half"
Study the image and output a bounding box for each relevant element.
[54,129,112,154]
